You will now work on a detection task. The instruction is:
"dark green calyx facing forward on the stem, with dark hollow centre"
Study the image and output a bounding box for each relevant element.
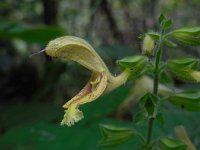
[140,93,157,118]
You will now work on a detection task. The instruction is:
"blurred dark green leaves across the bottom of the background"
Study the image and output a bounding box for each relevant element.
[0,87,200,150]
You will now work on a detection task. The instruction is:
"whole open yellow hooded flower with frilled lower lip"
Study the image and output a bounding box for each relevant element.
[45,36,130,126]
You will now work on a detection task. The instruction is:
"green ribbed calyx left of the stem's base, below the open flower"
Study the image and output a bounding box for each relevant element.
[100,125,134,146]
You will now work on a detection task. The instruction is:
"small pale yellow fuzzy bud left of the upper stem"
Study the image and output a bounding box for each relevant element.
[142,34,154,56]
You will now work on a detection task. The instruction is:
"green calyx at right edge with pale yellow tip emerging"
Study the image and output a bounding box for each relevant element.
[167,58,200,82]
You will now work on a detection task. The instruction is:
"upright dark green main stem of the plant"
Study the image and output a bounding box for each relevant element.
[146,29,164,150]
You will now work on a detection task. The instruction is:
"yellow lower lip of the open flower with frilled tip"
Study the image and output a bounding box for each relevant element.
[61,72,107,126]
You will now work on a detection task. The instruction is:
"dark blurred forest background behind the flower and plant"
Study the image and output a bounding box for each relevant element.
[0,0,200,150]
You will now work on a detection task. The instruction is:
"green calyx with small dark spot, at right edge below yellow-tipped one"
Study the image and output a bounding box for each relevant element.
[169,91,200,112]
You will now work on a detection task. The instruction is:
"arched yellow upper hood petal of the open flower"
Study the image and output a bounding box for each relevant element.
[45,36,107,72]
